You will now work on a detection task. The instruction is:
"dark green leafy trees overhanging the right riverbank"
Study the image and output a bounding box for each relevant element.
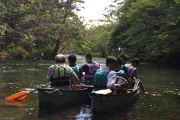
[110,0,180,63]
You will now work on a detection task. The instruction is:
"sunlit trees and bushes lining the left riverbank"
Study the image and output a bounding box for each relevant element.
[0,0,84,59]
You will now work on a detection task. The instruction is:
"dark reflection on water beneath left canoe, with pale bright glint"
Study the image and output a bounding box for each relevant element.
[38,104,92,120]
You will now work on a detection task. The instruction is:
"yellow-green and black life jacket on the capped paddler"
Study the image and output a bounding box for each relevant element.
[50,65,71,86]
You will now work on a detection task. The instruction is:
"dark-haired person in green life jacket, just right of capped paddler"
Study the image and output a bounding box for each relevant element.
[68,54,81,84]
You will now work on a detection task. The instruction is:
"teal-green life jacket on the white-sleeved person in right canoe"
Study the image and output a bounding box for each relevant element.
[94,69,112,91]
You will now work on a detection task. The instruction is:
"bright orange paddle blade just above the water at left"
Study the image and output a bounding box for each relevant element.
[4,92,29,101]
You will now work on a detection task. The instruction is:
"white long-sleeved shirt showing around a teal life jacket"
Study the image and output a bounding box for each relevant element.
[99,67,116,88]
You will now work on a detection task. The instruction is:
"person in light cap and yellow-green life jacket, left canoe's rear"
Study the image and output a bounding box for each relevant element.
[47,54,79,90]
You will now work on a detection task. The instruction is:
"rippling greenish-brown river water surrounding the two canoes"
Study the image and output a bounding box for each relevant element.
[0,56,180,120]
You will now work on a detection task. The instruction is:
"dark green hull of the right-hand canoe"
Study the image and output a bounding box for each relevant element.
[91,81,139,113]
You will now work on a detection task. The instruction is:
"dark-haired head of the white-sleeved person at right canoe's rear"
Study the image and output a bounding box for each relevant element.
[106,56,118,70]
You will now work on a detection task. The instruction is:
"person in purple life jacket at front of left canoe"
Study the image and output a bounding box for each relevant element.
[80,53,99,85]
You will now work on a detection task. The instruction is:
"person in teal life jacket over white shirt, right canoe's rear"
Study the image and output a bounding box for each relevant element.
[94,56,120,91]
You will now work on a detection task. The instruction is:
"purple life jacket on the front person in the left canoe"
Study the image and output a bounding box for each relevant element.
[85,63,99,79]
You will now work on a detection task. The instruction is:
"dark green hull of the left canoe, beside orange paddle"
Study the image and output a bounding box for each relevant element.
[38,87,93,108]
